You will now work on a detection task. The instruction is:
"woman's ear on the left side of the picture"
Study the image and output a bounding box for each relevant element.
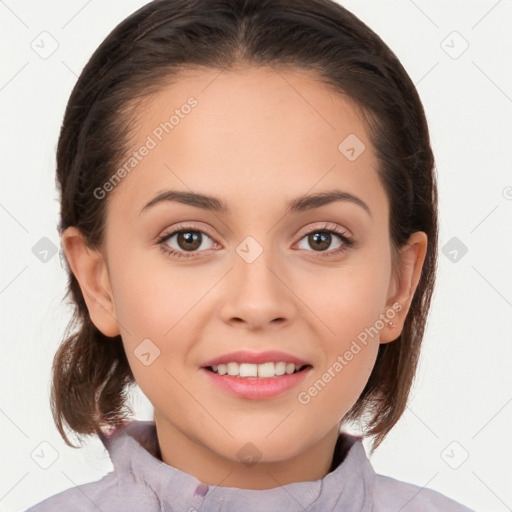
[62,227,120,337]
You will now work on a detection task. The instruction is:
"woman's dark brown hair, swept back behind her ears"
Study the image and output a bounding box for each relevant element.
[51,0,438,446]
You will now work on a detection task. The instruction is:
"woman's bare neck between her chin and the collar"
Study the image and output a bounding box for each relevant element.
[155,410,338,490]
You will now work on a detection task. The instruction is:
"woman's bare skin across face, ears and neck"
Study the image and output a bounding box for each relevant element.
[62,68,427,489]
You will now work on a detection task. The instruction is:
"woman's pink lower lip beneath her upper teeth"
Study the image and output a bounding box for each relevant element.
[201,367,311,400]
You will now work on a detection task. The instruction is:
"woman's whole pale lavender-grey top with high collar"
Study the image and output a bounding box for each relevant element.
[26,421,472,512]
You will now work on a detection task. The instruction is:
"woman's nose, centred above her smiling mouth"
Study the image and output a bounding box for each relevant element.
[221,251,297,330]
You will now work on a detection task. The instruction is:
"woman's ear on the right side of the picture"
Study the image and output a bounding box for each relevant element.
[380,231,427,343]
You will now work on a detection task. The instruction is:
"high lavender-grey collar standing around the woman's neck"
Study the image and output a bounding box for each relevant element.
[102,421,375,512]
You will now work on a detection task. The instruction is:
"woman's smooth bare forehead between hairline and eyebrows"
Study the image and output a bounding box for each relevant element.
[109,67,382,220]
